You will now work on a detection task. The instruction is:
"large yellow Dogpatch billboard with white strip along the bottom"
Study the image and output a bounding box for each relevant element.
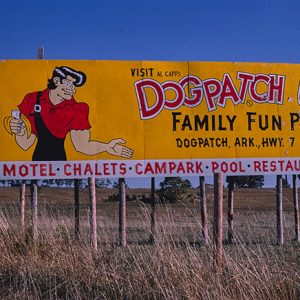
[0,60,300,179]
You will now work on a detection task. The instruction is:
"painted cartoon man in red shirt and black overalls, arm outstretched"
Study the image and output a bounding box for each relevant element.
[4,66,133,161]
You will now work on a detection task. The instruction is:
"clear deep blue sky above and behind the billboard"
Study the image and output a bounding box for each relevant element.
[0,0,300,186]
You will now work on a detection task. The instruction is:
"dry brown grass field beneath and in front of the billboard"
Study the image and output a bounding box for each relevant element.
[0,188,300,300]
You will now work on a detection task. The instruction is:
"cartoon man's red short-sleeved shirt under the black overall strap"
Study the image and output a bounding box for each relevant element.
[18,89,91,138]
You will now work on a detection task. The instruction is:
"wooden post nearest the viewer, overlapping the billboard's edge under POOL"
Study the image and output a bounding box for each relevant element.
[214,173,223,271]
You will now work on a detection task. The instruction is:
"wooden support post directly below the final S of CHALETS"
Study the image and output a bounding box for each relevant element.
[119,178,127,247]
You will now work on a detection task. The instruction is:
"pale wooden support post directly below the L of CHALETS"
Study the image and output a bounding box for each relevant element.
[88,177,98,251]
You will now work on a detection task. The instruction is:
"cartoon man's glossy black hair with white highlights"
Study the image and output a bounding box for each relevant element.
[47,66,86,90]
